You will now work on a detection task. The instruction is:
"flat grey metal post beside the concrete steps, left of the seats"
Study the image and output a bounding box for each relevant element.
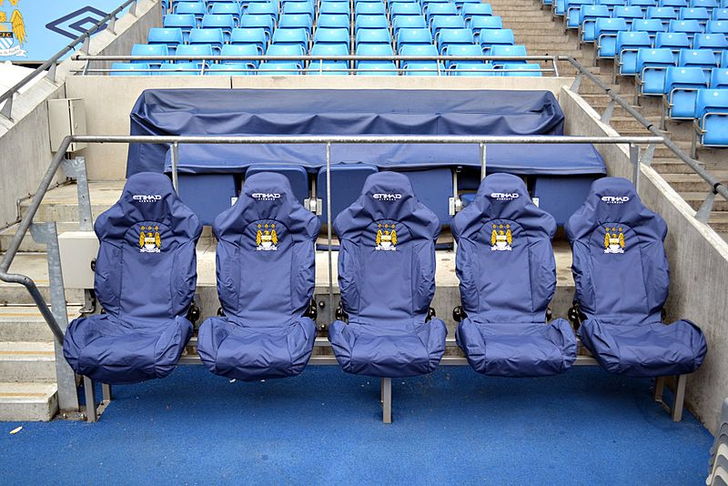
[30,223,79,416]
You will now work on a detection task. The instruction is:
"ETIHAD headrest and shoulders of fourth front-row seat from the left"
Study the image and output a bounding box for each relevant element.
[452,174,556,237]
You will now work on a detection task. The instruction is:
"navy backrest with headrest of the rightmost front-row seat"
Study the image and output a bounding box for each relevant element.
[565,177,670,324]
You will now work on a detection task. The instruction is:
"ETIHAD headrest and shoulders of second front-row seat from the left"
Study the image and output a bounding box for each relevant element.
[213,172,321,239]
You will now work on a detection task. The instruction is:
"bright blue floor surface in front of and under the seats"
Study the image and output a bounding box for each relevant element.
[0,366,712,486]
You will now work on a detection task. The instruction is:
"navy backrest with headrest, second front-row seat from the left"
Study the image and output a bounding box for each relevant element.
[213,172,321,326]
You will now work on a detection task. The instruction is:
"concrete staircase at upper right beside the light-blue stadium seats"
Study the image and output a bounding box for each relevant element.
[489,0,728,240]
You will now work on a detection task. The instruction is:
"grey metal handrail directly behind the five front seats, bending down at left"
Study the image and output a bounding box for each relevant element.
[0,135,665,344]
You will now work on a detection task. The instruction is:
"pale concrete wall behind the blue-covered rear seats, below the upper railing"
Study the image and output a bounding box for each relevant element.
[67,76,572,180]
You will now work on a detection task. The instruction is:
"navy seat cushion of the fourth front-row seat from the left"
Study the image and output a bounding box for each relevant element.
[456,319,576,377]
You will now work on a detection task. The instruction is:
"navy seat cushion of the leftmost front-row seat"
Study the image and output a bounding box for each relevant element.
[63,314,192,385]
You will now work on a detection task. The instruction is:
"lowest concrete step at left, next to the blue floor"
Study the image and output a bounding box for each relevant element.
[0,383,58,422]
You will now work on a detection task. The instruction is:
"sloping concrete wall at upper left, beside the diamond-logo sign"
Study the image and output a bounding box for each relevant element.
[0,0,161,228]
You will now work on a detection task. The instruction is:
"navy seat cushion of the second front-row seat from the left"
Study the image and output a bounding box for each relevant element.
[197,317,316,381]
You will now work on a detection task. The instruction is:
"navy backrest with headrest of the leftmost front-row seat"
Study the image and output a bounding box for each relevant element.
[94,172,202,328]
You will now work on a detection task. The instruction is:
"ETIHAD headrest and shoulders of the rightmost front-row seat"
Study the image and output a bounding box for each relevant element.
[566,177,667,239]
